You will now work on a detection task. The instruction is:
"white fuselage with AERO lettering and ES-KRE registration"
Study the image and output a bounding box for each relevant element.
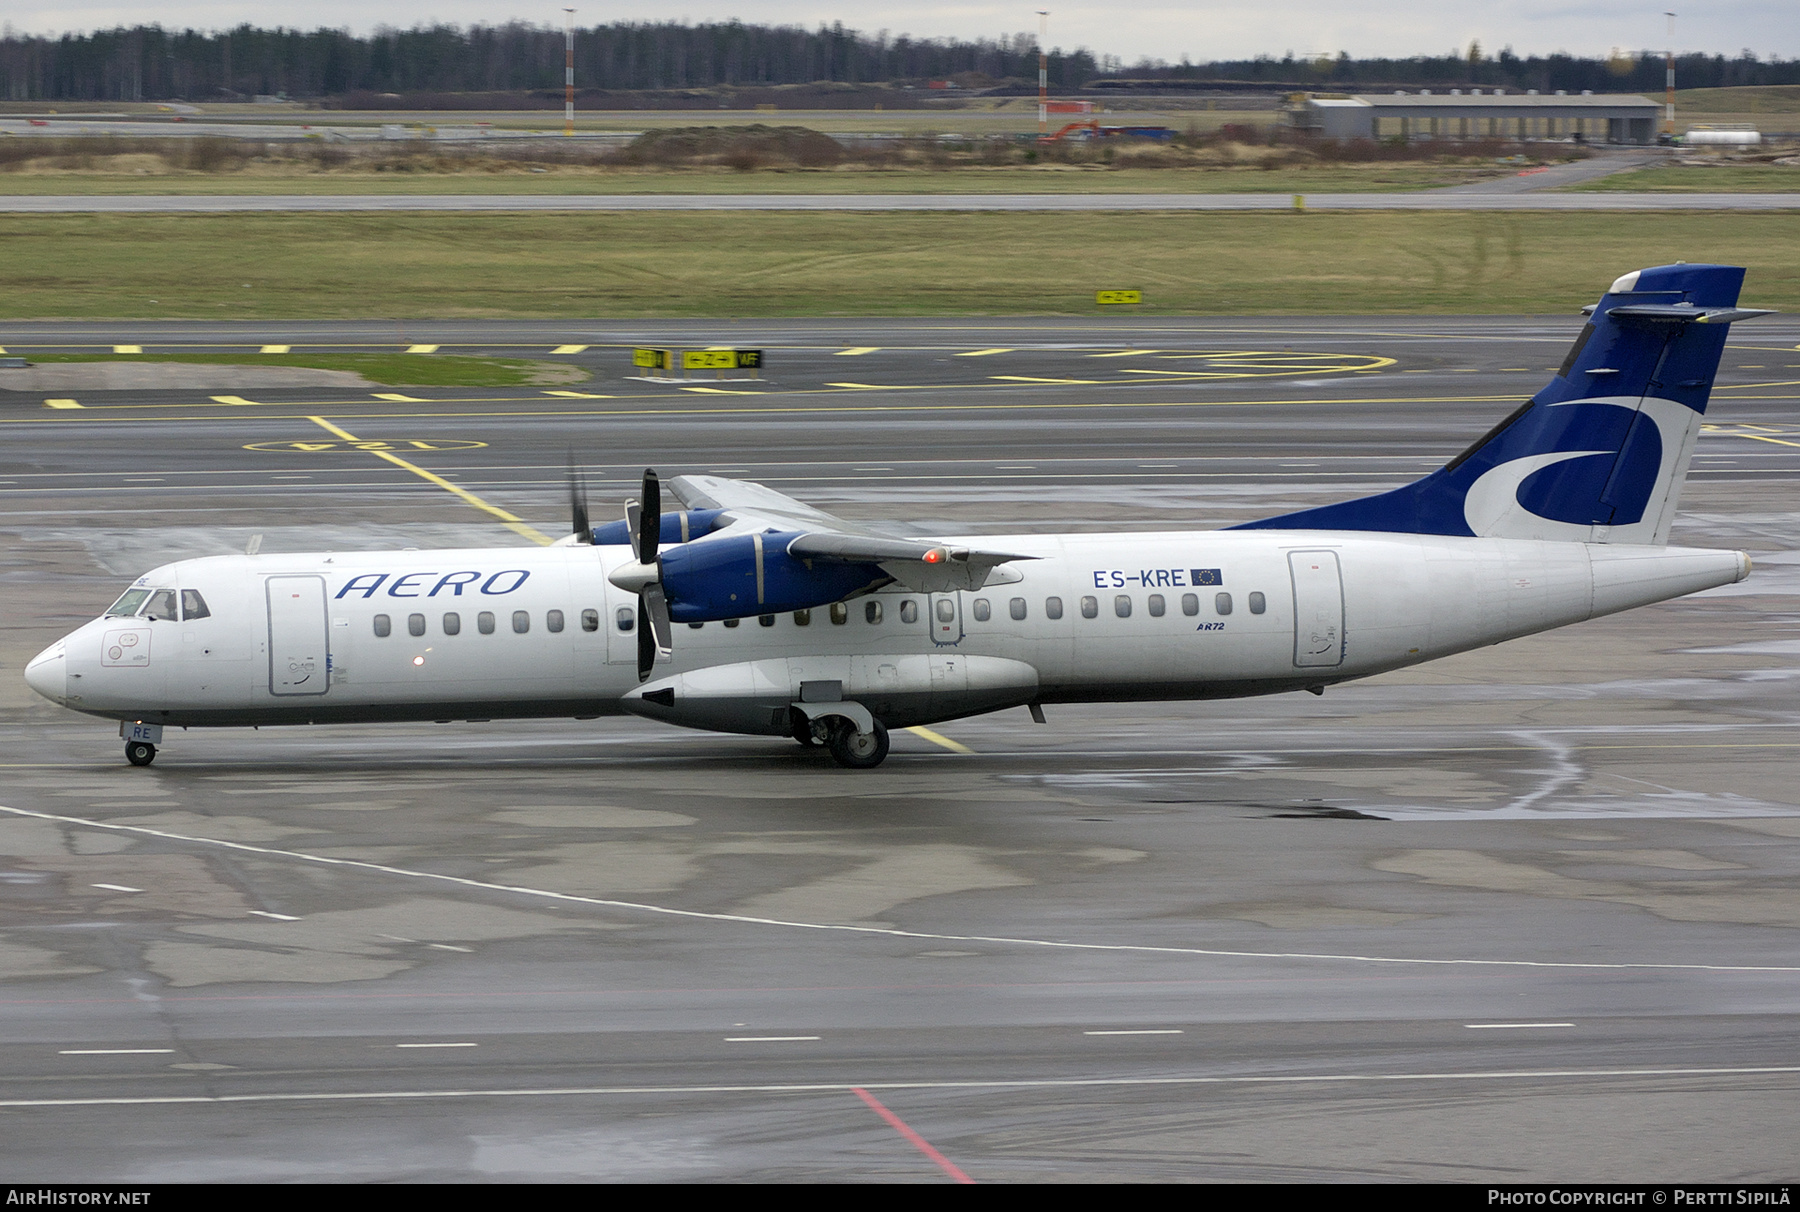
[27,529,1750,731]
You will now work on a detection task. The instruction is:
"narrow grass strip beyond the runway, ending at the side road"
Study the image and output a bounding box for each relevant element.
[0,157,1490,196]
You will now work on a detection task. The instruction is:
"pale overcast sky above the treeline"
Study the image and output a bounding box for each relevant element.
[0,0,1800,63]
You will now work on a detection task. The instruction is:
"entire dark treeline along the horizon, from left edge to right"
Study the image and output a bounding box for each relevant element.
[0,22,1800,101]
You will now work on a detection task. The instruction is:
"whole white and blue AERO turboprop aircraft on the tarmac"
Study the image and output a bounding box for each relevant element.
[25,265,1766,767]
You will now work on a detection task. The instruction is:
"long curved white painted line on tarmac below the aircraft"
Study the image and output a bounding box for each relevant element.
[0,806,1800,979]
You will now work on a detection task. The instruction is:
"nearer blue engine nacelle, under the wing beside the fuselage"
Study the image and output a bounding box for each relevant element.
[661,531,891,623]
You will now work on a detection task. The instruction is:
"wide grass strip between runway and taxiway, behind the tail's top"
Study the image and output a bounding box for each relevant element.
[0,211,1800,318]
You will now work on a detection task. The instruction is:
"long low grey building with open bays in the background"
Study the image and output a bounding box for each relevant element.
[1287,88,1661,144]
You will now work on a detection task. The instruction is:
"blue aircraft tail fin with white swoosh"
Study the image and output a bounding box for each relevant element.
[1233,265,1768,546]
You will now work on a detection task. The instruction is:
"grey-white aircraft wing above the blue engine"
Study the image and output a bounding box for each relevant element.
[668,475,1037,592]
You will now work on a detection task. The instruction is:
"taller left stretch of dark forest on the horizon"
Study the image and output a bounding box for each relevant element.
[0,22,1098,101]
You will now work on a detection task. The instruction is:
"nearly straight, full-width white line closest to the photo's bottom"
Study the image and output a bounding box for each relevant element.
[14,1048,1800,1108]
